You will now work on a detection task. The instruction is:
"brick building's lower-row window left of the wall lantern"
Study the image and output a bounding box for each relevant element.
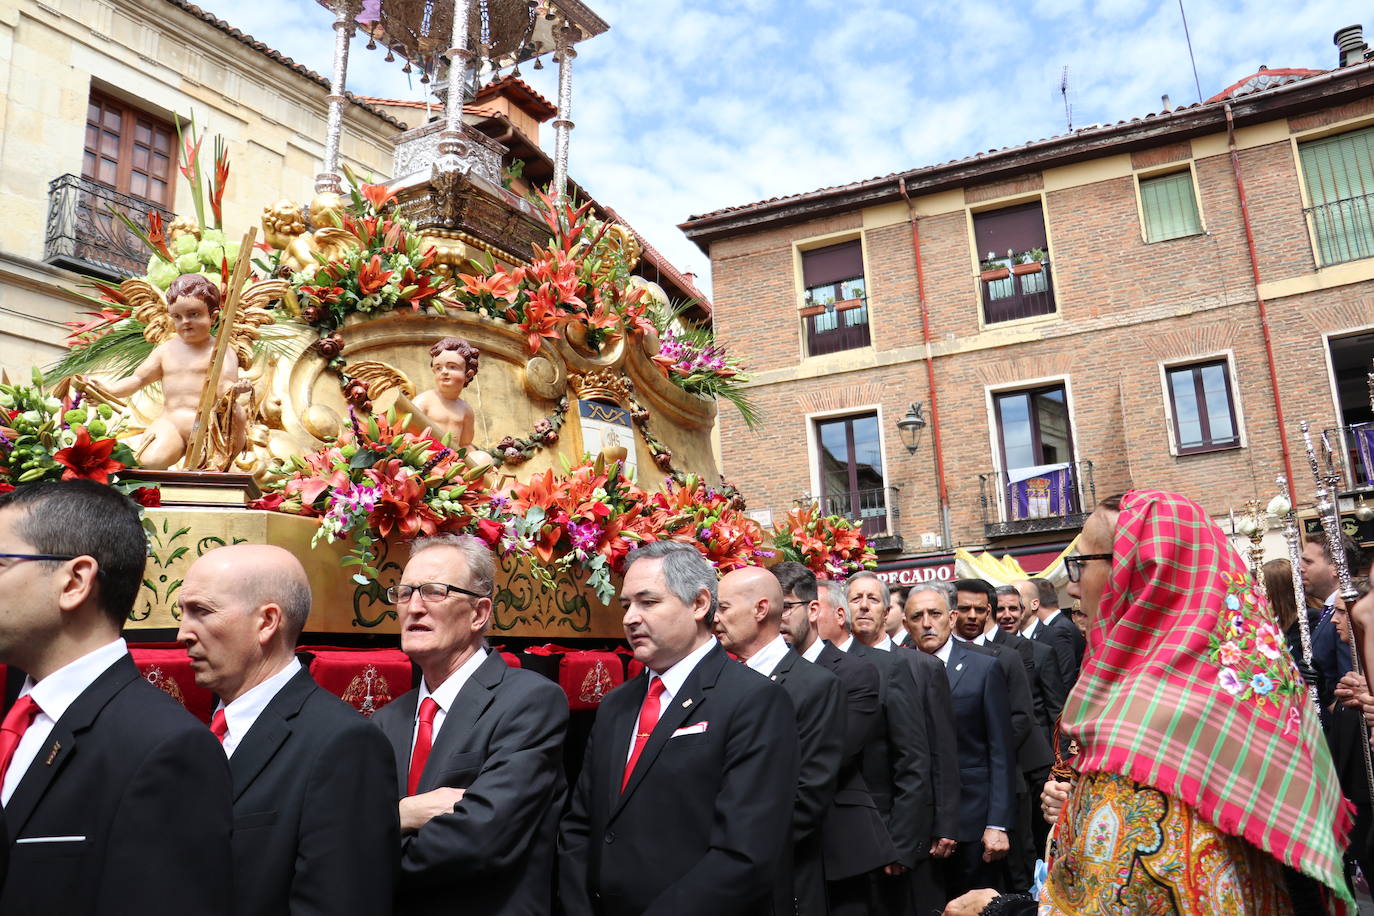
[816,413,888,536]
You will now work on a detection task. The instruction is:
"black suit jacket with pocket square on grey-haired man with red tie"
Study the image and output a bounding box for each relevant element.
[559,645,798,916]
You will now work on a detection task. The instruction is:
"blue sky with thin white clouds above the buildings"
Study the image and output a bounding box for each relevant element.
[202,0,1357,293]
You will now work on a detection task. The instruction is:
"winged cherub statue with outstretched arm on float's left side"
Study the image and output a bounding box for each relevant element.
[73,273,286,468]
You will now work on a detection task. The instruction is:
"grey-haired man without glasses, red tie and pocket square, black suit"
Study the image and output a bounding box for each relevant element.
[559,541,798,916]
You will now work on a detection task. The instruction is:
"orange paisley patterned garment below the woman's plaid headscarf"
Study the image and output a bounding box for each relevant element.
[1040,772,1293,916]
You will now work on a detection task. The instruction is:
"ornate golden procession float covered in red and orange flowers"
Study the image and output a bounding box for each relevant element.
[0,0,874,661]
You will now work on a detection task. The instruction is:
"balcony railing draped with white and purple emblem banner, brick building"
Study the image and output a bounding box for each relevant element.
[978,460,1098,538]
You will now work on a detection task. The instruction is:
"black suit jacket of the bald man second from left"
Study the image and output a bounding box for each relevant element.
[229,667,400,916]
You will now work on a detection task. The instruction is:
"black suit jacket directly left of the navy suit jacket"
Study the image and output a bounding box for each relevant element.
[849,640,936,868]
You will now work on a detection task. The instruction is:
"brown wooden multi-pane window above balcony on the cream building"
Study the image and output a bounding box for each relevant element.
[81,92,176,210]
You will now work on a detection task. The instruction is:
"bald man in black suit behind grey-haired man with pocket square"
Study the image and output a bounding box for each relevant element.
[714,566,845,916]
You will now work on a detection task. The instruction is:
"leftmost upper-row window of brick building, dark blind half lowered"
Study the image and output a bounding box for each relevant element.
[801,239,870,356]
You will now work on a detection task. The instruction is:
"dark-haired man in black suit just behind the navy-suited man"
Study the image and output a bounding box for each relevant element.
[954,580,1054,893]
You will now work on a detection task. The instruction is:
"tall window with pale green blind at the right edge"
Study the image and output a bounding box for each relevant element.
[1298,128,1374,266]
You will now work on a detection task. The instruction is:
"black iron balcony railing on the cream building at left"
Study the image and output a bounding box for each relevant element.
[43,174,174,280]
